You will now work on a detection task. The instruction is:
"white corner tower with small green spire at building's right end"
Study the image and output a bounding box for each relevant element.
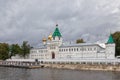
[106,34,115,59]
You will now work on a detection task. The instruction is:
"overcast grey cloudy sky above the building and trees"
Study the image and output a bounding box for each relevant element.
[0,0,120,46]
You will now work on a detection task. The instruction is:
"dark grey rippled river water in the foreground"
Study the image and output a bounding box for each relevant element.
[0,67,120,80]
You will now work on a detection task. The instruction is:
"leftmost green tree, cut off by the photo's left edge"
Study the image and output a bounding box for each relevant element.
[0,43,9,60]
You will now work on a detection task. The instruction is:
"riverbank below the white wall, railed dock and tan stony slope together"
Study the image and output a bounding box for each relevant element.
[0,61,120,71]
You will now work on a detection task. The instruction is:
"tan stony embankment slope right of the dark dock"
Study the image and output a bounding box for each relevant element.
[44,64,120,71]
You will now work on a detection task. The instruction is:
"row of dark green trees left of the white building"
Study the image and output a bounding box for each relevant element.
[0,41,31,60]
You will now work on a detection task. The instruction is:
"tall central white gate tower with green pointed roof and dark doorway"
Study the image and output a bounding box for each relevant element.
[47,24,62,59]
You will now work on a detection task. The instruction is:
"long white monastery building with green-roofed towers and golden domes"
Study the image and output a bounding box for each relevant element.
[29,25,115,60]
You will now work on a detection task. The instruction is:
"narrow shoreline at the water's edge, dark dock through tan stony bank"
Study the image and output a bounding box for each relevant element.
[0,63,120,71]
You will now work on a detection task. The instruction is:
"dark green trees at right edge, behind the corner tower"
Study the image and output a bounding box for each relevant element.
[112,31,120,56]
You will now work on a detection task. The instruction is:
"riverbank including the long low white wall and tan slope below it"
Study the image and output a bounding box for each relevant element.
[5,59,120,71]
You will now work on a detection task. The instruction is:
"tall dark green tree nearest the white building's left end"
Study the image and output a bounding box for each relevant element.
[21,41,31,58]
